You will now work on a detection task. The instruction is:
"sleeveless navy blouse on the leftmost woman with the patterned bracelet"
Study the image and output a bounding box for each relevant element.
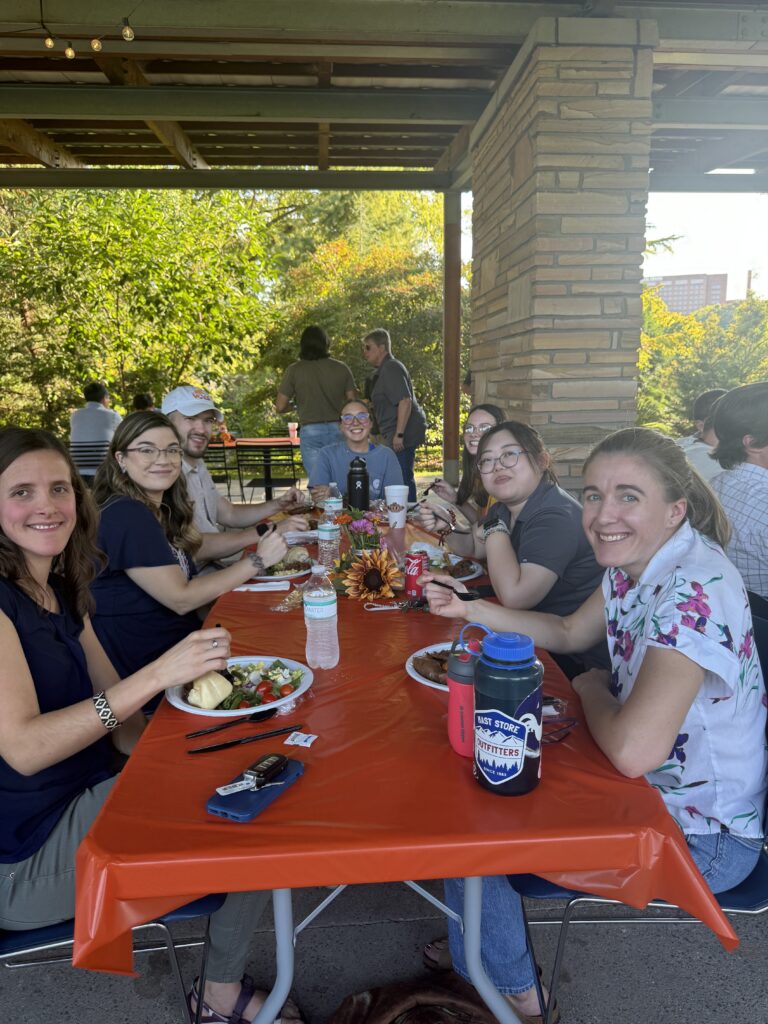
[0,577,114,864]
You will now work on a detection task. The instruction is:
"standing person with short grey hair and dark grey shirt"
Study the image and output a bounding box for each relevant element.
[362,328,427,502]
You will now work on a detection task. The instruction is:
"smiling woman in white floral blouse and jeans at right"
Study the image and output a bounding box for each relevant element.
[427,428,767,1020]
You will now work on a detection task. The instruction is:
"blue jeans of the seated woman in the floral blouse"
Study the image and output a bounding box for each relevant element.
[444,833,763,995]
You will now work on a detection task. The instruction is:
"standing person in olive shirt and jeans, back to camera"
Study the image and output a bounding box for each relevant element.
[274,325,357,476]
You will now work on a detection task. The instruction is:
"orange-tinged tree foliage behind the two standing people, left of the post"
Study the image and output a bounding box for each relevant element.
[226,193,466,440]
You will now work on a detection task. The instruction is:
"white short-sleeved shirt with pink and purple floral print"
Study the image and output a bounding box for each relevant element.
[603,522,768,838]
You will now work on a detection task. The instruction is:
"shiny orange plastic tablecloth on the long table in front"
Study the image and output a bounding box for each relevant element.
[74,593,738,973]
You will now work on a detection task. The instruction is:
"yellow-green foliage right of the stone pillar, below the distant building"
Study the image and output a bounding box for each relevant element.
[638,289,768,434]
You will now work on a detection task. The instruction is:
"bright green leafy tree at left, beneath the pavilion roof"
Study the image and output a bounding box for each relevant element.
[0,189,274,435]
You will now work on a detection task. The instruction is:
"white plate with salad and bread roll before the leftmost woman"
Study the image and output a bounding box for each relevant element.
[165,654,314,718]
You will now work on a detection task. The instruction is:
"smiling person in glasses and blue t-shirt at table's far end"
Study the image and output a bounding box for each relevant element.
[309,398,402,502]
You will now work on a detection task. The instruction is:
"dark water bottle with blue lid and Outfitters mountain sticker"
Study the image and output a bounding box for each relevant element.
[460,623,544,797]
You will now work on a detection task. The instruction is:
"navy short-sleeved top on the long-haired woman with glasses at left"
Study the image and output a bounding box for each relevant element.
[91,497,201,679]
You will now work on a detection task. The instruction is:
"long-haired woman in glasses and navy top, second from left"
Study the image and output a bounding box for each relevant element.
[87,411,287,674]
